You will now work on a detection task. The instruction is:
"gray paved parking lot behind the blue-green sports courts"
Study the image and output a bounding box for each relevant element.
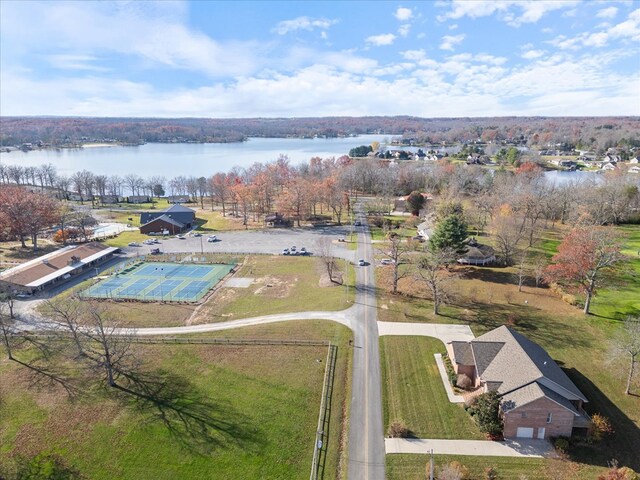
[123,226,362,261]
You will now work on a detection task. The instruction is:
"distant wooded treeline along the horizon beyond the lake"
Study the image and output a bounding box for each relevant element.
[0,116,640,149]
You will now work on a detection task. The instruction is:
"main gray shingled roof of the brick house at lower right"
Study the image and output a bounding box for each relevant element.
[471,326,588,402]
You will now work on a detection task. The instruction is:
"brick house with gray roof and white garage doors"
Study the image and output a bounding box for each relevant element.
[447,326,591,439]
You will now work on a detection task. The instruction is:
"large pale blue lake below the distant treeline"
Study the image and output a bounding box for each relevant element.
[0,135,392,178]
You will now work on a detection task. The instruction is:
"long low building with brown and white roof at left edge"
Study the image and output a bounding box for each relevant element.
[0,242,120,294]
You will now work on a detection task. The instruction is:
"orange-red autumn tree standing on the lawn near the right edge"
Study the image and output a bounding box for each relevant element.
[546,227,623,314]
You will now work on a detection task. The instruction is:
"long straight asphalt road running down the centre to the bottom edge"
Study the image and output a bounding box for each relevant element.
[347,205,385,480]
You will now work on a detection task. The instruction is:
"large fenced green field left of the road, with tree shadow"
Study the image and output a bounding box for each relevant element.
[0,323,350,479]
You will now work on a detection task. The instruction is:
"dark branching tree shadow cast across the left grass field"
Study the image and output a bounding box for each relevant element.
[116,370,261,455]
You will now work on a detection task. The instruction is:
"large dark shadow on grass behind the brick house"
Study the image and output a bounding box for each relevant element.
[564,368,640,471]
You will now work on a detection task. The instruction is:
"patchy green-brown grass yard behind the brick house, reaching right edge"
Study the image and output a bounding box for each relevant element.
[376,226,640,472]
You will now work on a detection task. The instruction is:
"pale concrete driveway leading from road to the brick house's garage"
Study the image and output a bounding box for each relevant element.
[384,438,555,458]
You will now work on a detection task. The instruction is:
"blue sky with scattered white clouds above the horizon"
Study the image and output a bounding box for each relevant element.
[0,0,640,118]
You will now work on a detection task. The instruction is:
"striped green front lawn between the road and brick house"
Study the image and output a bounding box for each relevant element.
[380,336,485,440]
